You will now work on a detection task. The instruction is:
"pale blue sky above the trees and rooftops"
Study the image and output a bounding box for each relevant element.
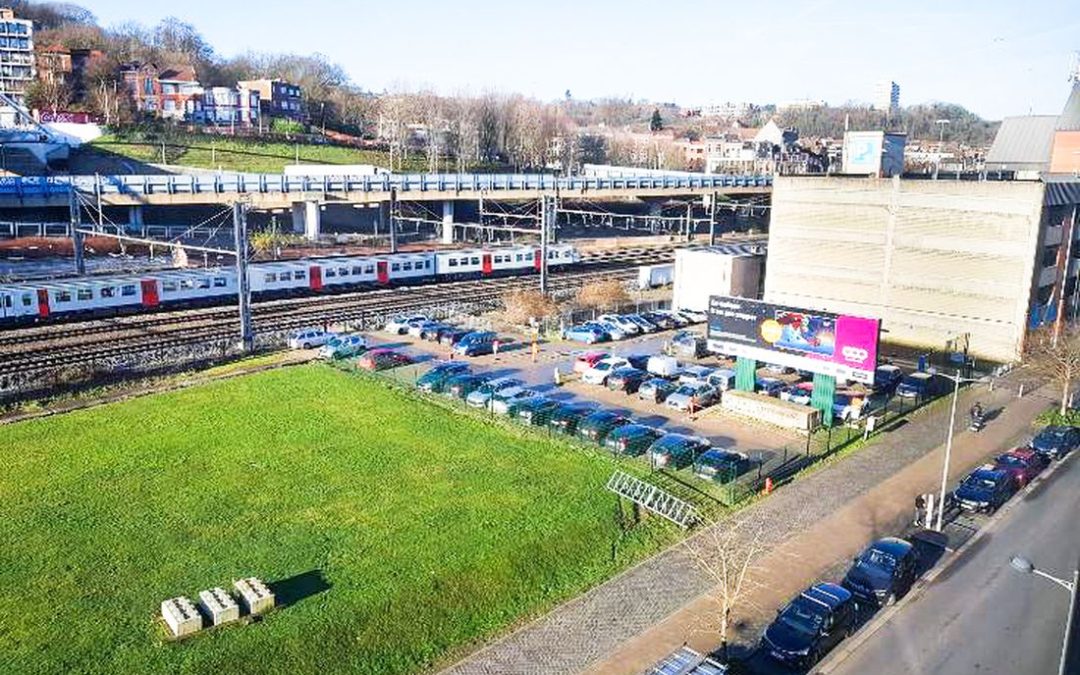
[86,0,1080,119]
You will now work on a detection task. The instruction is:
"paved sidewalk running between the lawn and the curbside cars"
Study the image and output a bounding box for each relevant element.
[446,373,1050,674]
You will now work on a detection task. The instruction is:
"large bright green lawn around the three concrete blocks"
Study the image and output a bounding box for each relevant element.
[0,365,679,674]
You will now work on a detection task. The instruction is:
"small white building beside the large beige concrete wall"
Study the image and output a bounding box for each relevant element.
[672,244,765,312]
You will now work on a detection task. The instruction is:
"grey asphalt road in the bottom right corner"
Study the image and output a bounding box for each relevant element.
[833,456,1080,675]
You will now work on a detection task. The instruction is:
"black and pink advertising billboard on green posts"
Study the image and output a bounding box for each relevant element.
[708,296,881,384]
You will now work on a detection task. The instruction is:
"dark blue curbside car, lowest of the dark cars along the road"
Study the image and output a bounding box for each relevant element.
[761,583,858,670]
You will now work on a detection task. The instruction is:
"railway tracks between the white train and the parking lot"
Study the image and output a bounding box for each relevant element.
[0,240,699,380]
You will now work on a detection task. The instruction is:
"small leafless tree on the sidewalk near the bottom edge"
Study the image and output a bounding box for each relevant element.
[683,517,797,661]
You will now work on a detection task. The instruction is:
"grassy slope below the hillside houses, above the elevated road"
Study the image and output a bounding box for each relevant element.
[81,135,427,174]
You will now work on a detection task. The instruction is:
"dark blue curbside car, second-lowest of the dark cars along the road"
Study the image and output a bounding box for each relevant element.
[842,537,919,606]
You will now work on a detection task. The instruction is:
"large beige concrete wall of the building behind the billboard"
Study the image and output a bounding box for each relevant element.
[765,177,1043,362]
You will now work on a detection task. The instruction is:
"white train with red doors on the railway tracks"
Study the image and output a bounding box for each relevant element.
[0,244,579,326]
